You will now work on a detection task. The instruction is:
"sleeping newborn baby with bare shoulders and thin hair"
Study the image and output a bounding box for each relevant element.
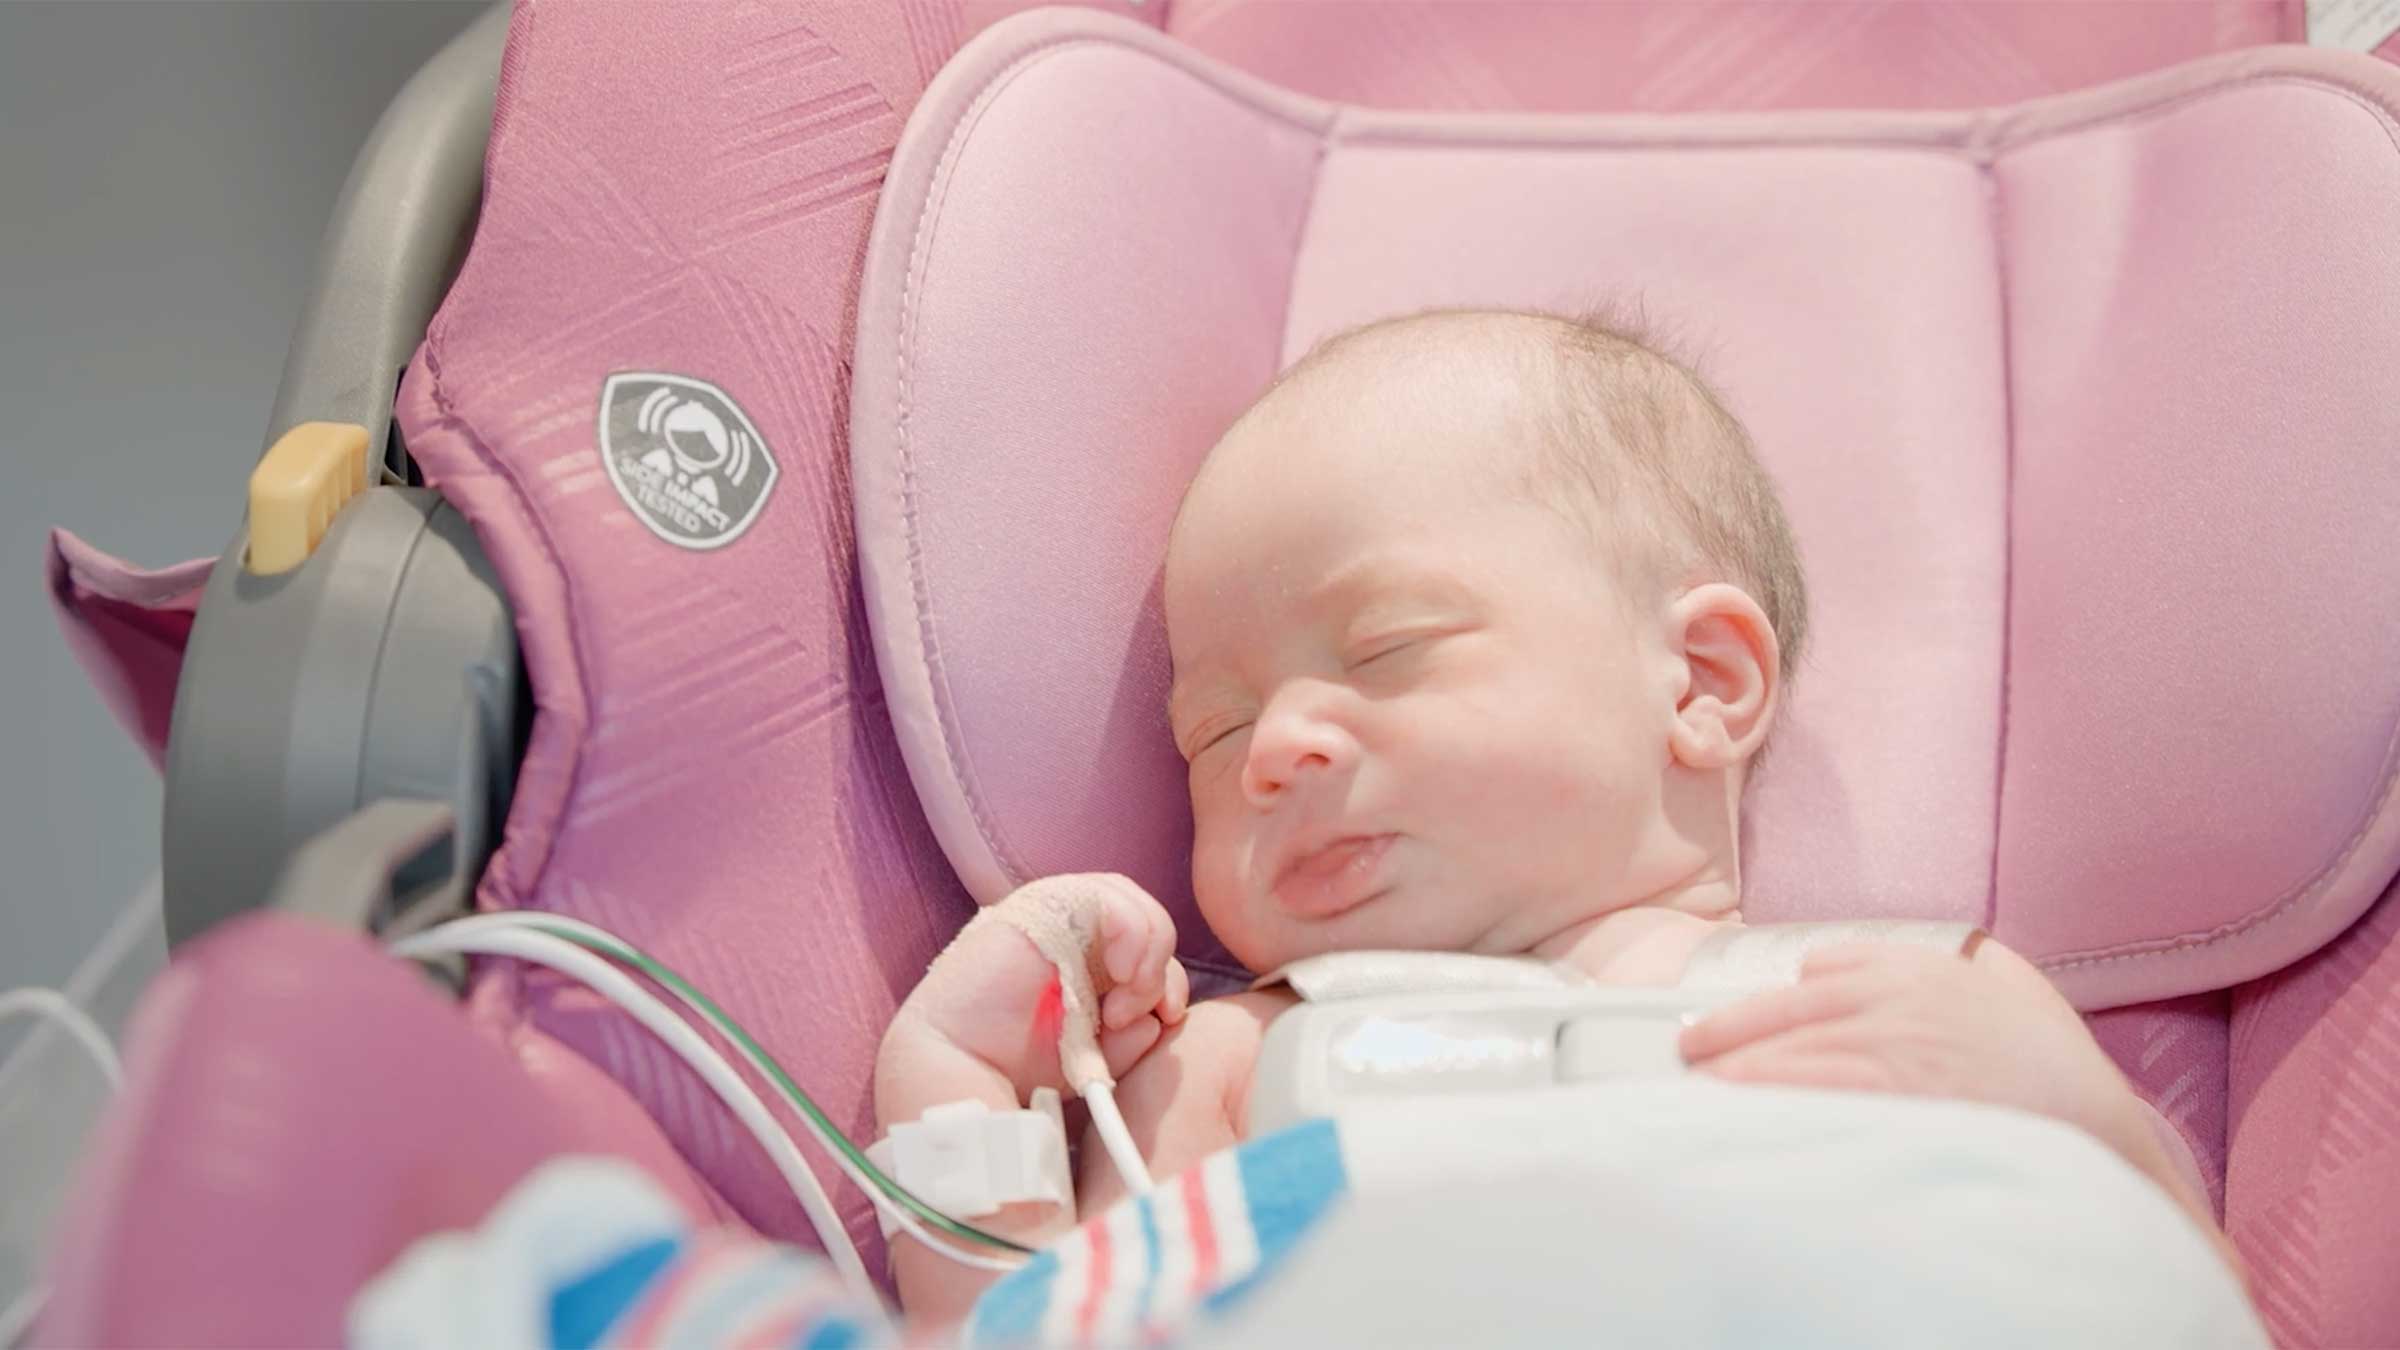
[876,312,2239,1319]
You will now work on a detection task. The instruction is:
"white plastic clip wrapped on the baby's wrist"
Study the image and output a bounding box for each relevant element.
[866,1088,1075,1237]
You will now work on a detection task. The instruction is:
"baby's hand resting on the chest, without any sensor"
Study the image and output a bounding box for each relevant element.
[1682,942,2146,1151]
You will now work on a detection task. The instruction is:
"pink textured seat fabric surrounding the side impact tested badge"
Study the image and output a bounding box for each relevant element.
[396,0,1041,1268]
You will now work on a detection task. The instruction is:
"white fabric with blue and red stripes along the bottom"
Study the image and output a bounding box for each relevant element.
[350,1119,1349,1350]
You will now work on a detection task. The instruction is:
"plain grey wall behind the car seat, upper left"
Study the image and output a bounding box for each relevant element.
[0,0,482,1004]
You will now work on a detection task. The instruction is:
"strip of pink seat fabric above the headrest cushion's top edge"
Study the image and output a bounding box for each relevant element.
[1164,0,2342,113]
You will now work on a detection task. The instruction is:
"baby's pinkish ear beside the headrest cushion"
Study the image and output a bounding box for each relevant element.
[1666,581,1783,769]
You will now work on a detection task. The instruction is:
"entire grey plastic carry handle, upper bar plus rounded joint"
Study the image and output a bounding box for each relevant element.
[161,5,530,944]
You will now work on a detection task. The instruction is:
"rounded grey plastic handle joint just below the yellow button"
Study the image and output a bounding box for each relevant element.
[158,488,533,946]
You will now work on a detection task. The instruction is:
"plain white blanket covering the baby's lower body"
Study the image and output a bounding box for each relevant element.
[1195,1076,2268,1350]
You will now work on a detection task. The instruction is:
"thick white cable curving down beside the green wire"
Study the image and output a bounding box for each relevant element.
[391,925,883,1307]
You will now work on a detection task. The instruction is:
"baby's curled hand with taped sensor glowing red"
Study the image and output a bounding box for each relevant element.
[886,872,1190,1098]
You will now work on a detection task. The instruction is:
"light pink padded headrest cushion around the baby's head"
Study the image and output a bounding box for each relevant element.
[852,12,2400,1009]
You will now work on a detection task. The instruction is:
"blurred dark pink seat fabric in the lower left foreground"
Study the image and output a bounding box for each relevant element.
[41,915,722,1345]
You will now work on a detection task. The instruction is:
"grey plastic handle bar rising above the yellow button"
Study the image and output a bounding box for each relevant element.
[264,0,509,459]
